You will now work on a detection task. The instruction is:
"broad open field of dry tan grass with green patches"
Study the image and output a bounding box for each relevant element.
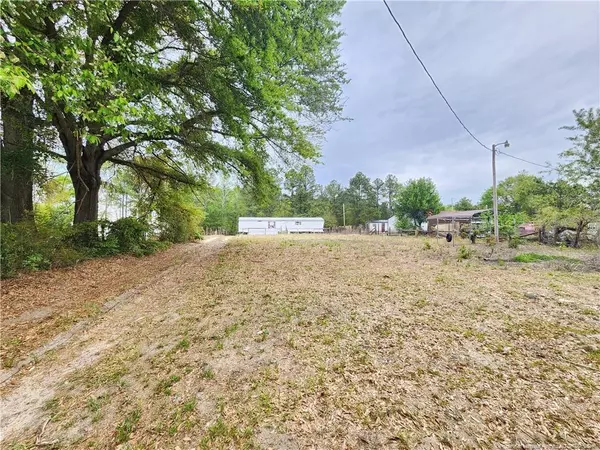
[1,236,600,449]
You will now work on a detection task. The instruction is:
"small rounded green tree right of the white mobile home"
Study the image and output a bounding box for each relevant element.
[395,178,442,227]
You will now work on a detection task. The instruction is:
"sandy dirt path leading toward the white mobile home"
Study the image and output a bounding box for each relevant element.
[0,236,226,444]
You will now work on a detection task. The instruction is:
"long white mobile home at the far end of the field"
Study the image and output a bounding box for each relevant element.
[238,217,325,235]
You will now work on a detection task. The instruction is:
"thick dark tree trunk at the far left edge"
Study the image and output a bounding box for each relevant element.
[0,90,35,222]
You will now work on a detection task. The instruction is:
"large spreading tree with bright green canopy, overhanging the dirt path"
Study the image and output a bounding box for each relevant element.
[0,0,346,222]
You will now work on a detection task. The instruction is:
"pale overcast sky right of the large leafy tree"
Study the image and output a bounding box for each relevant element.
[315,0,600,203]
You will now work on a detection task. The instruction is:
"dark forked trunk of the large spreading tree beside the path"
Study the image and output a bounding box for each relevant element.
[68,151,101,223]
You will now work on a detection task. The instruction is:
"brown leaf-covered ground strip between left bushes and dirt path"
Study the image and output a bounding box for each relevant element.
[0,245,199,369]
